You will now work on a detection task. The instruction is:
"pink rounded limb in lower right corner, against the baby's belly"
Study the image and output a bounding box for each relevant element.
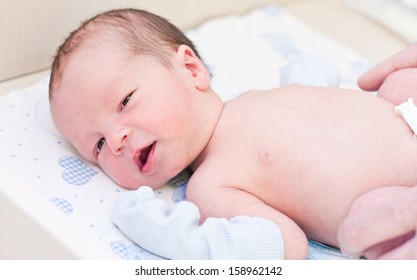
[338,186,417,259]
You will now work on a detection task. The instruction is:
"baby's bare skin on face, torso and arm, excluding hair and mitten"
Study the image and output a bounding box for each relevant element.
[51,42,417,259]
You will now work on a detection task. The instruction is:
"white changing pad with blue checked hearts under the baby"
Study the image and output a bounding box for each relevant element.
[0,6,370,259]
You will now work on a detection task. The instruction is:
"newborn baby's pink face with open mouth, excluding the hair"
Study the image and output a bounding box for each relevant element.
[51,43,213,189]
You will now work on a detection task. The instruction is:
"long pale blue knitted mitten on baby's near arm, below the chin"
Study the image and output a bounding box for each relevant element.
[112,187,284,259]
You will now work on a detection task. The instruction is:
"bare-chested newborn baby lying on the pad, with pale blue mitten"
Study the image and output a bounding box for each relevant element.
[50,9,417,259]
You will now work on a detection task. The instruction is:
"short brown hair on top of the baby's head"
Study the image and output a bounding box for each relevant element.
[49,9,200,99]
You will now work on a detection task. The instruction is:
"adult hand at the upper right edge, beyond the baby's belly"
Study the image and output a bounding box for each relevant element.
[358,42,417,91]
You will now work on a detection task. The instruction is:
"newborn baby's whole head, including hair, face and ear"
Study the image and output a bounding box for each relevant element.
[49,9,222,189]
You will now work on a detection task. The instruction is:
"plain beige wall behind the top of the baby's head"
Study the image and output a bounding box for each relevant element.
[0,0,294,81]
